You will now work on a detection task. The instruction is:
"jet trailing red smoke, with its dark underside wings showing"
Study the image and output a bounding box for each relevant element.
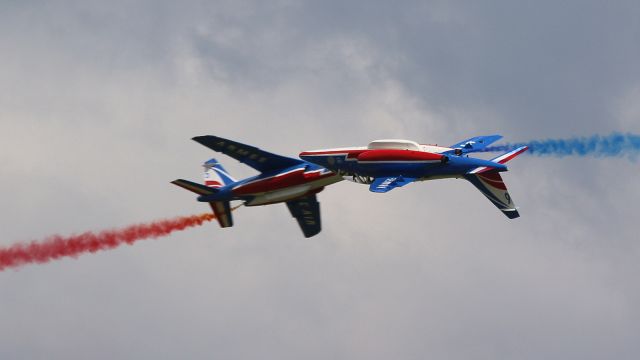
[171,135,343,238]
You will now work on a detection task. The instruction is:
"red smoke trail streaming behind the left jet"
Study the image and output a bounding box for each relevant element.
[0,213,215,271]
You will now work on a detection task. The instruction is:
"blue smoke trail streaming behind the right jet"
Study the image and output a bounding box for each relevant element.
[483,133,640,159]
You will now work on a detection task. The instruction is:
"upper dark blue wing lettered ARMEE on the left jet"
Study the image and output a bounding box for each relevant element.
[193,135,305,173]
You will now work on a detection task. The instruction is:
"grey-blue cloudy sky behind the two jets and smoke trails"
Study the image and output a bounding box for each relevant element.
[0,1,640,359]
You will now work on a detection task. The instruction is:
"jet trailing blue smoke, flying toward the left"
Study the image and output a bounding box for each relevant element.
[300,135,528,219]
